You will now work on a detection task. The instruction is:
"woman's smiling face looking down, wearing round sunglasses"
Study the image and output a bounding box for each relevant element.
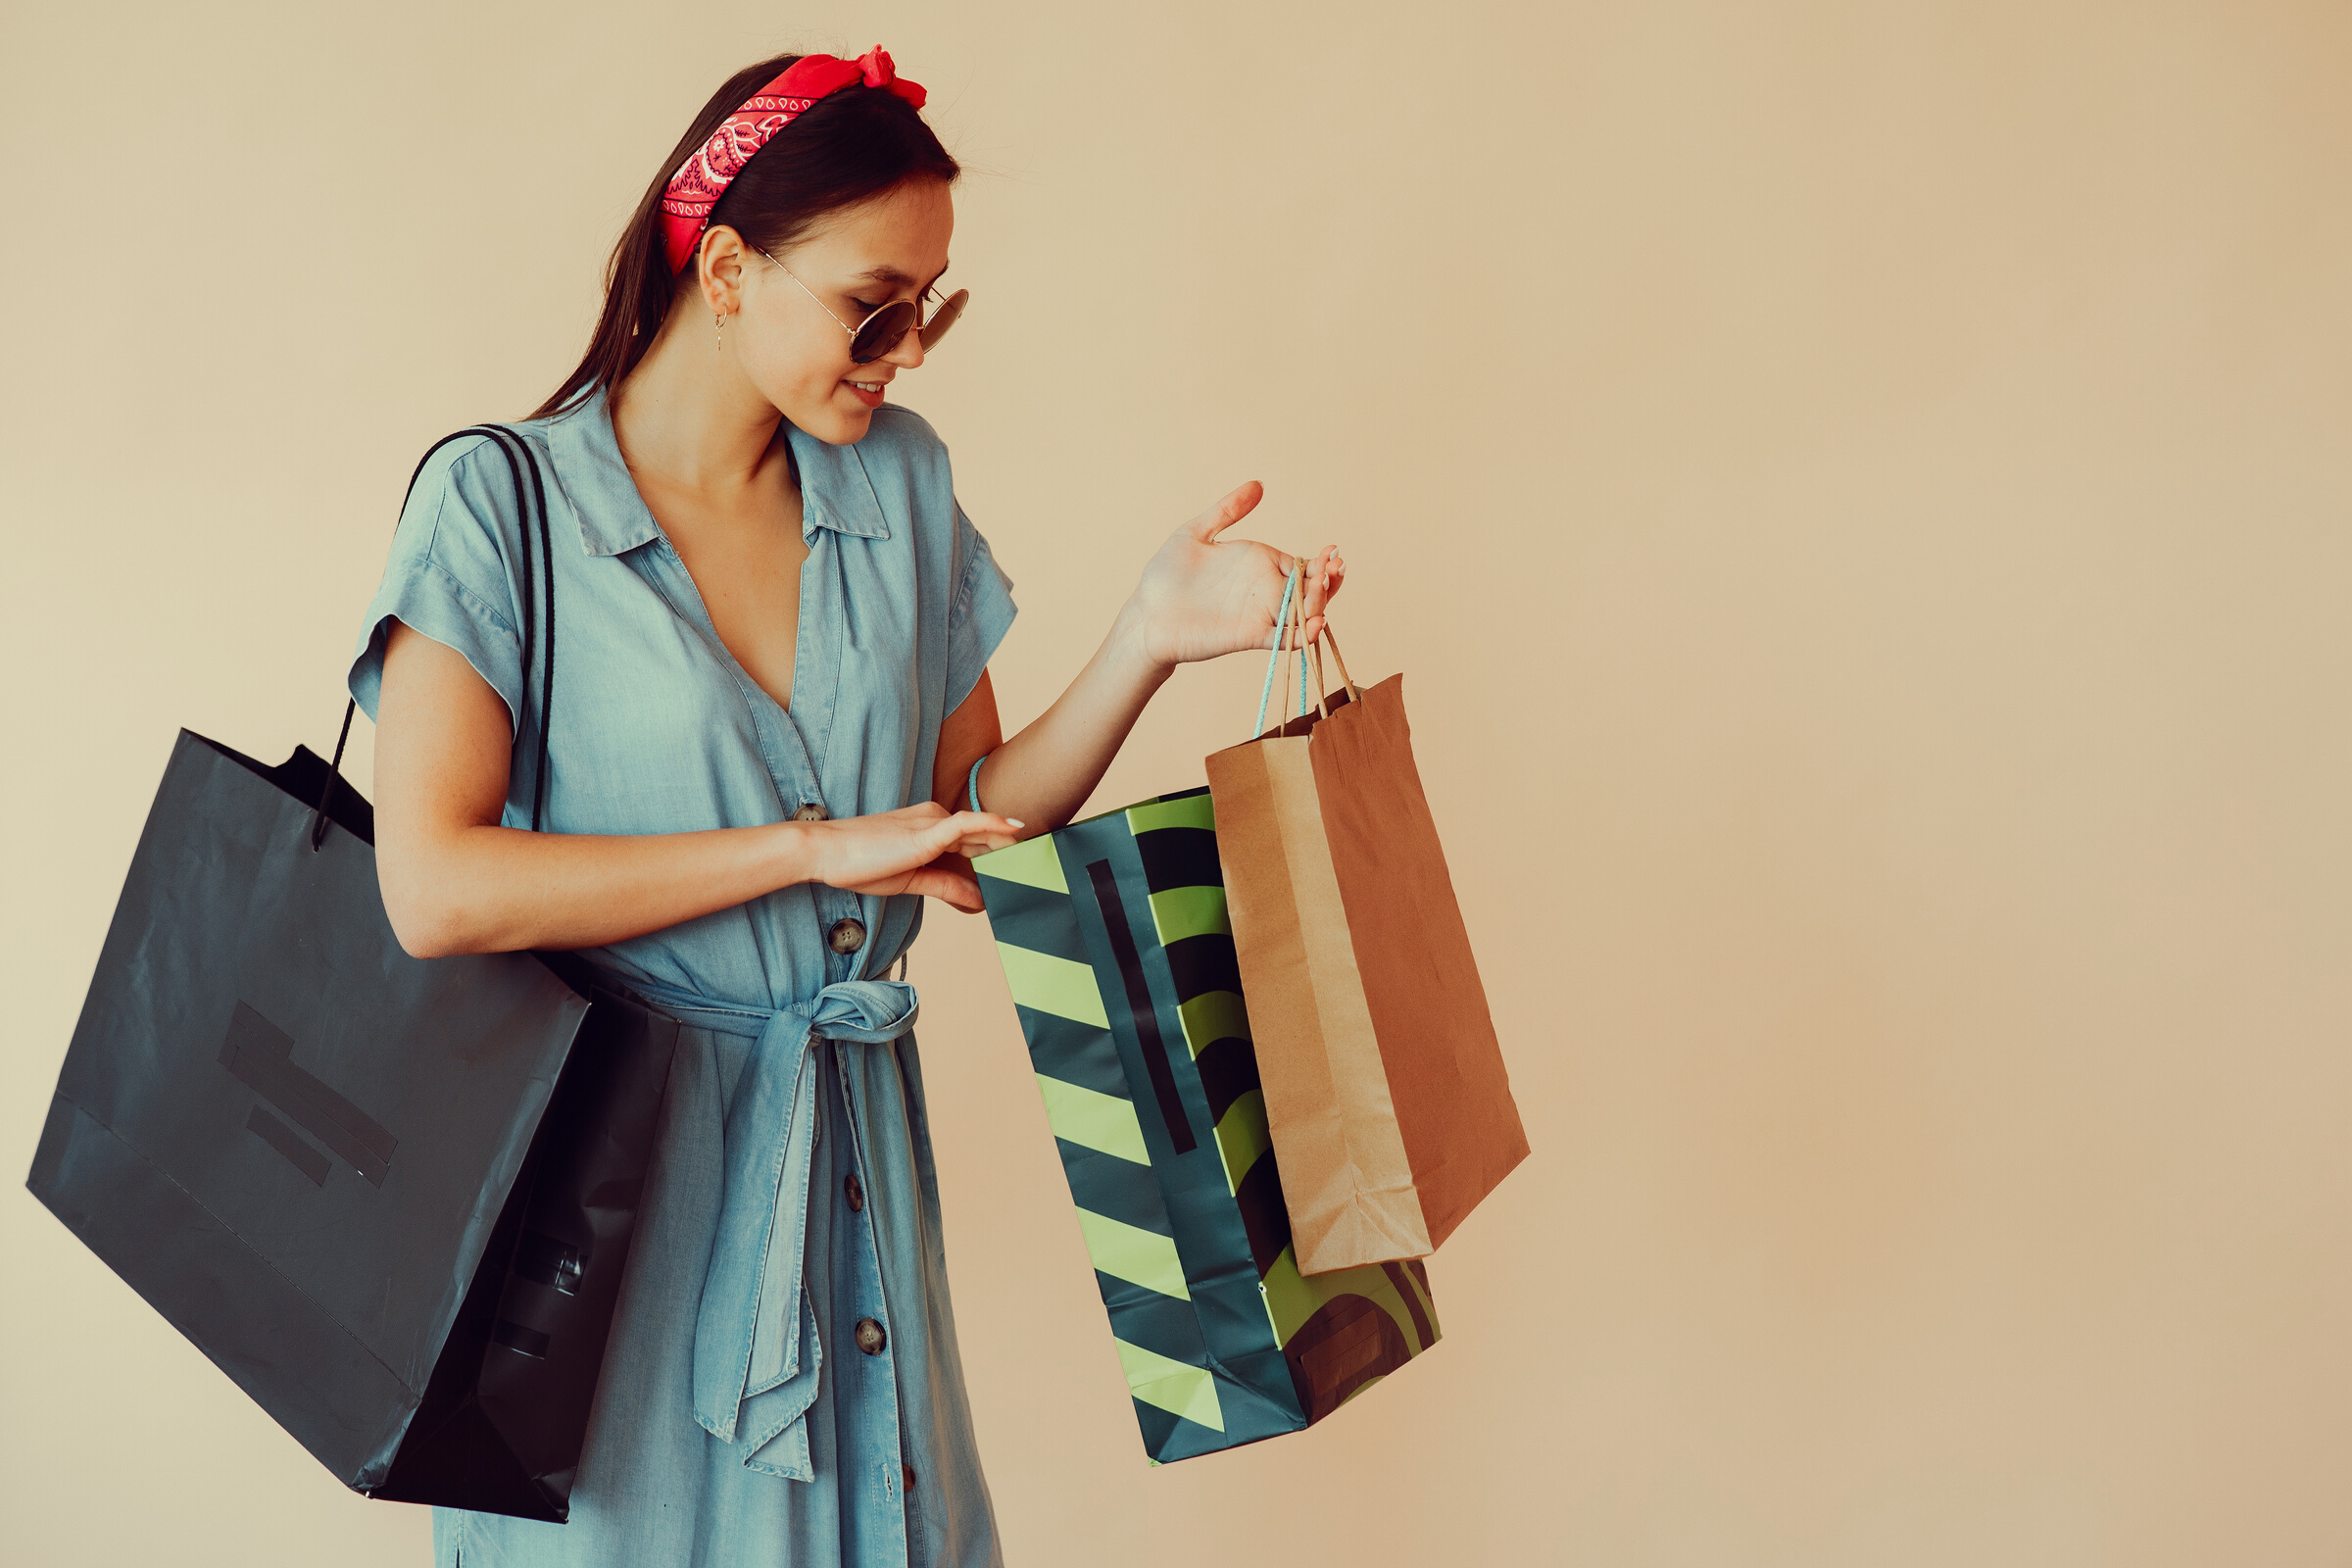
[724,178,955,447]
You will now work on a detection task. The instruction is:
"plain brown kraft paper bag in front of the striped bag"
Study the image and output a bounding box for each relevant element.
[1206,602,1527,1274]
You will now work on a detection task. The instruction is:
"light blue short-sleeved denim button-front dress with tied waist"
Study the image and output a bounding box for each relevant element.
[351,383,1013,1568]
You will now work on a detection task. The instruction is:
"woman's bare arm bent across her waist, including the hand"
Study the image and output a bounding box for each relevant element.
[376,623,1016,956]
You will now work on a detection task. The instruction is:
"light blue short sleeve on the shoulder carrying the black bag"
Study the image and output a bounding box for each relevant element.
[351,437,522,726]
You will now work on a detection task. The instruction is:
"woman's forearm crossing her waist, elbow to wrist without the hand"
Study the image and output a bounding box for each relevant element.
[376,823,813,959]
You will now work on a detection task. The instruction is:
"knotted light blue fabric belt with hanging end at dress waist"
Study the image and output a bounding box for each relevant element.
[630,980,917,1481]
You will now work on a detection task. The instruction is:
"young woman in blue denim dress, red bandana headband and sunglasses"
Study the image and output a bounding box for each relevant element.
[351,49,1343,1568]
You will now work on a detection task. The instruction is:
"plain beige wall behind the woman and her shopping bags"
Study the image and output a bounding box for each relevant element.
[0,0,2352,1568]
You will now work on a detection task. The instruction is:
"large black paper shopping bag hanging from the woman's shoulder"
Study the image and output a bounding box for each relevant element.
[28,432,677,1521]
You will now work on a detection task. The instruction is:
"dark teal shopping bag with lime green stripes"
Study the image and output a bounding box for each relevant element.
[971,790,1437,1462]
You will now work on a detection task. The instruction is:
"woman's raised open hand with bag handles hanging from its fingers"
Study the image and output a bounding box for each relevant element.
[1127,479,1348,667]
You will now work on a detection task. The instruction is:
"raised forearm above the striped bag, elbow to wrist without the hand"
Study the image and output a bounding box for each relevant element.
[981,602,1174,835]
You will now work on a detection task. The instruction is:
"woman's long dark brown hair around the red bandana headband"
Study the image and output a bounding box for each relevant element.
[531,54,962,418]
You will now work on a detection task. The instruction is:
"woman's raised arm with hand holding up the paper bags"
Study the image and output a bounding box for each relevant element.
[931,479,1348,837]
